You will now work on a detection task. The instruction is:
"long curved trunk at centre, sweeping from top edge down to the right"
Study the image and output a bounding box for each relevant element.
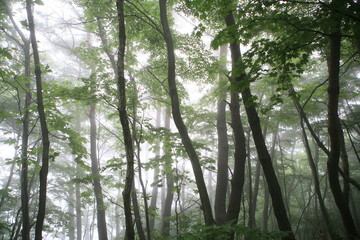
[159,0,214,225]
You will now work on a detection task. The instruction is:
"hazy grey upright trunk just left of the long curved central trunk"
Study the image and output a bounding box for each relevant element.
[161,109,174,236]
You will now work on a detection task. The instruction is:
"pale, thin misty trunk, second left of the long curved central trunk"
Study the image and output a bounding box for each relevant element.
[149,107,161,229]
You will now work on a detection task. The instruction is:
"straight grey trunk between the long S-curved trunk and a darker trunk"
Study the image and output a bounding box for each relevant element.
[214,44,229,225]
